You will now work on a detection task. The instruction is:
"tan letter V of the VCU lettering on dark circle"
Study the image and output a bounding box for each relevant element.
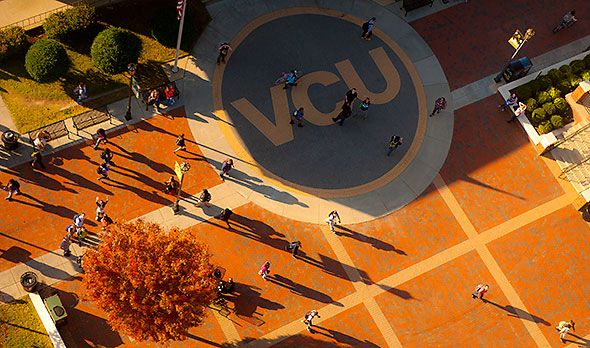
[231,85,293,146]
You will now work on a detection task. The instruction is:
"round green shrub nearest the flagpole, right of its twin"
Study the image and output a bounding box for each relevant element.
[90,27,141,75]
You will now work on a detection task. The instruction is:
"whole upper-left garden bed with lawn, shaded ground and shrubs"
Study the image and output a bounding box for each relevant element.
[0,0,210,133]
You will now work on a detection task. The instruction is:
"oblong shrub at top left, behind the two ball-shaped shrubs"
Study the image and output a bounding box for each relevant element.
[43,3,96,39]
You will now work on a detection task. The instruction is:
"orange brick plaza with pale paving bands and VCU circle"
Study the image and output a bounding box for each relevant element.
[0,0,590,347]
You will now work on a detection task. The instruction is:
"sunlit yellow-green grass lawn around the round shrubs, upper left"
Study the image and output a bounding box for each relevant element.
[0,29,180,133]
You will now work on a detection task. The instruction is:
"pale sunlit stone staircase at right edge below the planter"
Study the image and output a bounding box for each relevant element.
[551,122,590,192]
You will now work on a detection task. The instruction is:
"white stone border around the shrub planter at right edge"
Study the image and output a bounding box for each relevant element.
[498,52,590,148]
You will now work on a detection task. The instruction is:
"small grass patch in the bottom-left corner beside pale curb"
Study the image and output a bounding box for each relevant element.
[0,296,53,348]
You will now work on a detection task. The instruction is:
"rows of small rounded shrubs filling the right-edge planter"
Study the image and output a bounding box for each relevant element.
[512,55,590,134]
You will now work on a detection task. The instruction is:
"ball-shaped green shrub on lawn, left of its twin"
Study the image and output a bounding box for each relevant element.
[25,39,70,82]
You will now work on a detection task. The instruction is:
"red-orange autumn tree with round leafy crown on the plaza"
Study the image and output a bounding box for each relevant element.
[84,220,216,342]
